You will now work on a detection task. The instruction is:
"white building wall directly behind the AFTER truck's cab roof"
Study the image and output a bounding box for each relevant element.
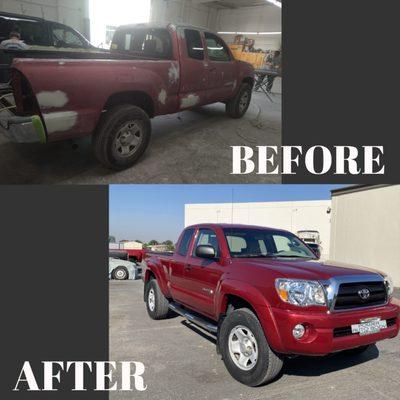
[185,200,331,259]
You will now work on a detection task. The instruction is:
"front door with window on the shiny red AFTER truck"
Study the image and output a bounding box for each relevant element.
[184,228,226,317]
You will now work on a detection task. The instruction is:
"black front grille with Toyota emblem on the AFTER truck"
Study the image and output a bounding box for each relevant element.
[335,282,387,310]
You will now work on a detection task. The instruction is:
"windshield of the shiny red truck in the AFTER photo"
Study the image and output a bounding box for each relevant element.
[224,228,316,259]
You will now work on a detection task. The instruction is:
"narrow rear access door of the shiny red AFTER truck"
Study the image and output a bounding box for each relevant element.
[169,229,195,303]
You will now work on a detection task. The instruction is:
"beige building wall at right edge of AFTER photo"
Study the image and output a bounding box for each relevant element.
[330,185,400,287]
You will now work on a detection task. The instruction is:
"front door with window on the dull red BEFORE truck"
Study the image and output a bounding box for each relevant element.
[204,32,239,103]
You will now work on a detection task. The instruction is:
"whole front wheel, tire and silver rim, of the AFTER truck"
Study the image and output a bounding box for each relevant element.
[219,308,283,387]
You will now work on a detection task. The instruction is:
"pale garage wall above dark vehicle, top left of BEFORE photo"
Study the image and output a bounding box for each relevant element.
[0,0,89,37]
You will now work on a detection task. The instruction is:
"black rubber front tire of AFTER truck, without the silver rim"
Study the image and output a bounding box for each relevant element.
[219,308,283,387]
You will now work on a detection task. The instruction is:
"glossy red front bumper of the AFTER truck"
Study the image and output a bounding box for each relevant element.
[266,304,400,355]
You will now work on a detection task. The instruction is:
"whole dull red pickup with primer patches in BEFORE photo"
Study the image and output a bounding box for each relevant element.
[0,24,254,169]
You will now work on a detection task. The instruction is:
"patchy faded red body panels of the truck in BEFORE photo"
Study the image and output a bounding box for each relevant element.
[3,25,254,142]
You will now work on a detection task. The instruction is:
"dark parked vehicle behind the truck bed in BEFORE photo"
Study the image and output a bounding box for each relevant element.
[0,12,101,84]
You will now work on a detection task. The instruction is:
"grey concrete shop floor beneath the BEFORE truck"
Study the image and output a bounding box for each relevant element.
[0,88,282,184]
